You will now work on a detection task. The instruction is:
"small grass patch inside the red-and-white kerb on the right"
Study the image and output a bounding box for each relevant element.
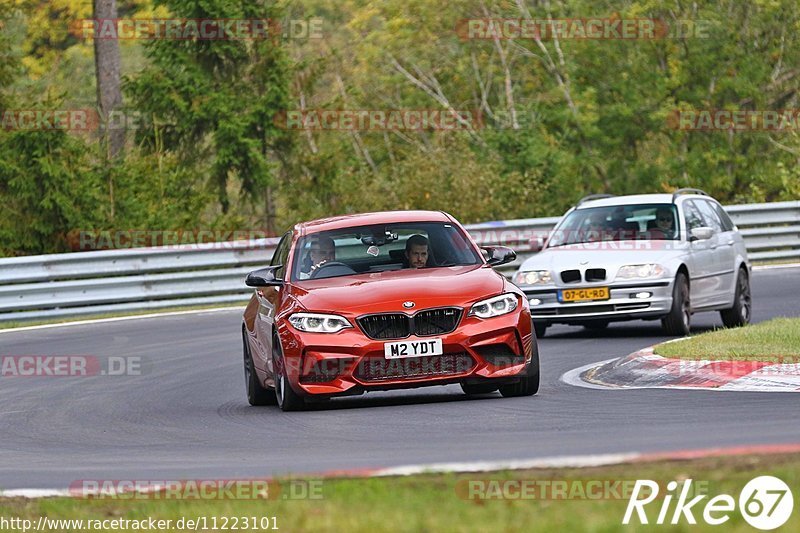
[653,318,800,363]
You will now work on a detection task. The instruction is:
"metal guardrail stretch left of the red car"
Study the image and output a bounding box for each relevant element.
[0,239,278,322]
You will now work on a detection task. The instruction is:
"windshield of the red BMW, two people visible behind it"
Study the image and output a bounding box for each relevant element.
[292,222,481,281]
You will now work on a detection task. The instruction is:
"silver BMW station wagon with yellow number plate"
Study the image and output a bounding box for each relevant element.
[513,189,752,337]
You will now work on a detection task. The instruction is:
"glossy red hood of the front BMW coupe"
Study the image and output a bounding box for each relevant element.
[292,265,506,316]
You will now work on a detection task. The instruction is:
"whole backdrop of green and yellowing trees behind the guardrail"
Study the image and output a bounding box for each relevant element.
[0,0,800,253]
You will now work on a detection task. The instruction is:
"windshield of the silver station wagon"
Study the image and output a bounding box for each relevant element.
[547,204,680,248]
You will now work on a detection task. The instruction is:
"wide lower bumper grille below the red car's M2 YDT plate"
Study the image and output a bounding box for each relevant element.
[353,353,475,382]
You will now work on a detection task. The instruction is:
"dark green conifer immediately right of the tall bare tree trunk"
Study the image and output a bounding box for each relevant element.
[126,0,289,213]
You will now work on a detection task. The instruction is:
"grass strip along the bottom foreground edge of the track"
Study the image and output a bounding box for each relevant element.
[0,454,800,532]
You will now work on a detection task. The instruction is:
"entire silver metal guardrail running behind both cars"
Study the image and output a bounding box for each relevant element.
[0,201,800,322]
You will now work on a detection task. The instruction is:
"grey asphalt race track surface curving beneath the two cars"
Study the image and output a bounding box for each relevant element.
[0,268,800,489]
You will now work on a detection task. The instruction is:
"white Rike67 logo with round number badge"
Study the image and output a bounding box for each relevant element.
[622,476,794,531]
